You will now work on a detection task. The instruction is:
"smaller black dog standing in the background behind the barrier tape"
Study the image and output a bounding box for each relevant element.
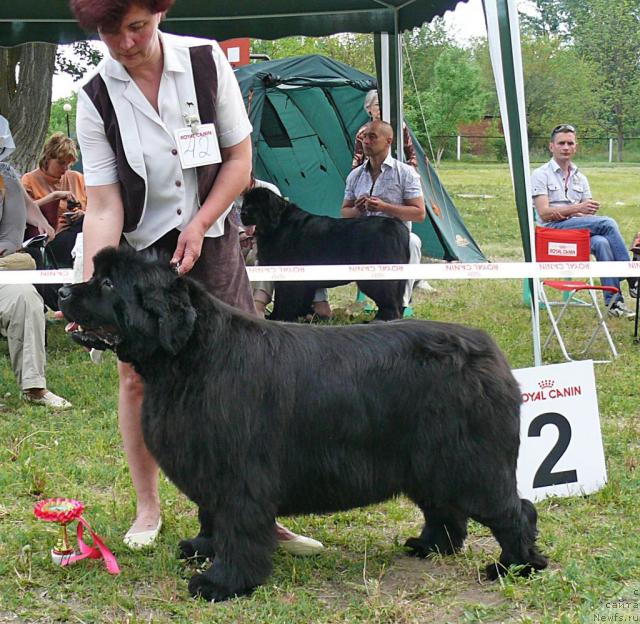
[241,188,409,321]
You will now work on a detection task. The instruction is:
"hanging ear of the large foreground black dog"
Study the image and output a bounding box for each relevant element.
[140,277,196,355]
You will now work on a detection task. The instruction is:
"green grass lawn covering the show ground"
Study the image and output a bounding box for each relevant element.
[0,164,640,624]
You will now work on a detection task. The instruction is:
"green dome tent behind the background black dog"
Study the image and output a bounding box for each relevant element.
[236,55,486,262]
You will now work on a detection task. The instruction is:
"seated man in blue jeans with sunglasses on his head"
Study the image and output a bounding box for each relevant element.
[531,124,635,318]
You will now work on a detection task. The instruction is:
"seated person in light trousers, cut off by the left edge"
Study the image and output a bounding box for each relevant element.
[0,115,71,409]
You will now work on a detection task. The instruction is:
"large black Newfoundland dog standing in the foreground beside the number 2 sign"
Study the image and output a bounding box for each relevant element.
[60,249,547,600]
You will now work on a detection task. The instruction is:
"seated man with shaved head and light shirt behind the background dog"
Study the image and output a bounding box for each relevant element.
[340,119,427,308]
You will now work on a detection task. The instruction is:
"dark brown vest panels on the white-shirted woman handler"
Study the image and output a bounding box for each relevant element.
[83,45,220,232]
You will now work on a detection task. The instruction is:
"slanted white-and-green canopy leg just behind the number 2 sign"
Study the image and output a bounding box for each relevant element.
[483,0,542,366]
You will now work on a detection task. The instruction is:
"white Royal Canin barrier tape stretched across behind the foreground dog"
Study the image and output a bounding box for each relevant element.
[0,260,640,284]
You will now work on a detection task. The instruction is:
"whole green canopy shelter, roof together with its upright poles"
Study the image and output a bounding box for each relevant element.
[0,0,541,364]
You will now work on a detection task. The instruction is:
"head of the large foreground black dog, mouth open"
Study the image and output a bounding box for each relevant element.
[58,247,196,363]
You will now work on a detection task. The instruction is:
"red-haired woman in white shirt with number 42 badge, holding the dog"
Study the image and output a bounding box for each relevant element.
[70,0,322,554]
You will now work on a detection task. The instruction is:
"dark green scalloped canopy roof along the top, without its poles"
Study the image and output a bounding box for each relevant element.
[0,0,470,46]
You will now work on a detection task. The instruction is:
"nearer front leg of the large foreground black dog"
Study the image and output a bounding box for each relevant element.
[189,497,277,602]
